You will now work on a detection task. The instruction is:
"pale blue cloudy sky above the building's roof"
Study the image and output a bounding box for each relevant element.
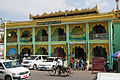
[0,0,117,21]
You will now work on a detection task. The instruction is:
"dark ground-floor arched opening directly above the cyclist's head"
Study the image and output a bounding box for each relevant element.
[51,47,66,59]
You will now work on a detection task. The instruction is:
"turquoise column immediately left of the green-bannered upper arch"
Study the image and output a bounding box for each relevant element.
[66,24,70,65]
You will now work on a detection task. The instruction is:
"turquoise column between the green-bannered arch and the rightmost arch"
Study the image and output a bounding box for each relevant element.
[86,22,90,68]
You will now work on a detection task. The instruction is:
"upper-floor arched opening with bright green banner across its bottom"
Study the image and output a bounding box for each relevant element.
[69,26,85,40]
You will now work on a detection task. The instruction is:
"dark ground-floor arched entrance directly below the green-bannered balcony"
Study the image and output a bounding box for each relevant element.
[73,46,86,61]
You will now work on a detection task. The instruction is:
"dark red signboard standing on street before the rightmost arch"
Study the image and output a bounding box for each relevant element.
[92,57,104,71]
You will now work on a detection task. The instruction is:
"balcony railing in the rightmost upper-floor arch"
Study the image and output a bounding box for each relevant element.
[89,33,109,40]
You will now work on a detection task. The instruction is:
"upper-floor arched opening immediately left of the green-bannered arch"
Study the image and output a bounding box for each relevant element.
[52,27,66,41]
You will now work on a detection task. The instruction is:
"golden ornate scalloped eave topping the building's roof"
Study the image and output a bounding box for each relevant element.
[29,5,99,19]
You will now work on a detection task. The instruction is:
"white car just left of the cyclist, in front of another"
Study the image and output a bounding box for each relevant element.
[38,57,57,70]
